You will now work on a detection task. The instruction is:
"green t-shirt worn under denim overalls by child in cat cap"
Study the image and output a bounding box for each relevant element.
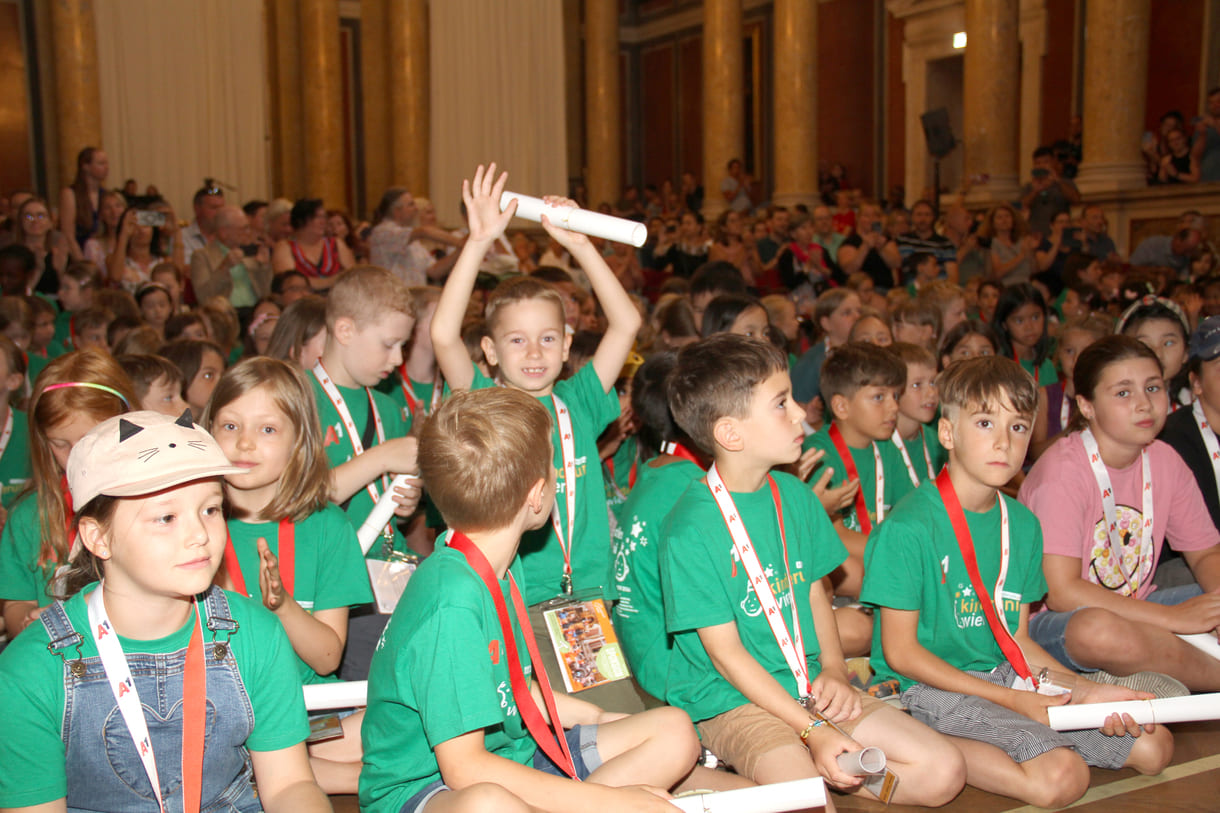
[0,587,309,807]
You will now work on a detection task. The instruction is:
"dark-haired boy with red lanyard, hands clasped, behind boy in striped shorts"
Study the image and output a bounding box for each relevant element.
[804,342,911,596]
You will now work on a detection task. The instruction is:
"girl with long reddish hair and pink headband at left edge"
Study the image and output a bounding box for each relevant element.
[0,349,138,640]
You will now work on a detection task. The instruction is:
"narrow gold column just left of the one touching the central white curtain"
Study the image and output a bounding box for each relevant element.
[360,0,393,215]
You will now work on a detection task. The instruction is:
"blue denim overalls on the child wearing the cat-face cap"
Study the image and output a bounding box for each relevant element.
[39,587,262,813]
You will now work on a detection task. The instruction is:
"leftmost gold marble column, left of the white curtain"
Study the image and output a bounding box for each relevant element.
[51,0,102,184]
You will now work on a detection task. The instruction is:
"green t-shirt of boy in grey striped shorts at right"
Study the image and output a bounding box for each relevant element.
[860,481,1047,690]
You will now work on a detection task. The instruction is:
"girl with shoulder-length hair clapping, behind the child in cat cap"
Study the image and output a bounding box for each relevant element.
[203,358,373,793]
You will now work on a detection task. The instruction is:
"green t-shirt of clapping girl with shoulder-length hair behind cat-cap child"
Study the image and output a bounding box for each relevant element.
[228,504,373,684]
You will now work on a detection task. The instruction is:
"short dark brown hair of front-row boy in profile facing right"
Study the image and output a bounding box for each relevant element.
[669,333,788,453]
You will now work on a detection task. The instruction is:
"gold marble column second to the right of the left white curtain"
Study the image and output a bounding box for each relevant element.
[298,0,348,209]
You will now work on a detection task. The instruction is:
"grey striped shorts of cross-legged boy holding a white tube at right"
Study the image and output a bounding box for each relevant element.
[903,663,1136,769]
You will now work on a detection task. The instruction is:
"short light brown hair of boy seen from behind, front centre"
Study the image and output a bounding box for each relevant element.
[418,387,554,532]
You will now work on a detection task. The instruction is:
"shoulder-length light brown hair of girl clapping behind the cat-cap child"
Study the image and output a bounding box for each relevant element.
[199,355,331,522]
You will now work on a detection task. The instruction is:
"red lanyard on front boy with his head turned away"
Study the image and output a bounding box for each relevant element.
[449,531,577,779]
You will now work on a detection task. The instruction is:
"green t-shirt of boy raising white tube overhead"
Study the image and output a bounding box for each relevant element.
[471,364,619,604]
